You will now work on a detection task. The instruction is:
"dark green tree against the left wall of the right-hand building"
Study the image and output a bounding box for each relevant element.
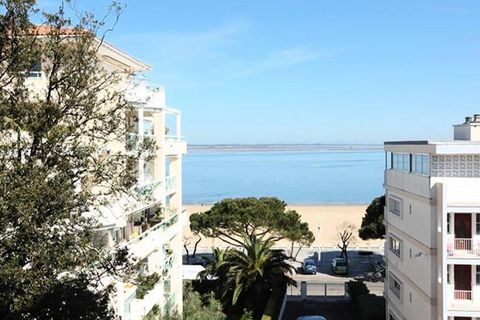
[358,196,385,240]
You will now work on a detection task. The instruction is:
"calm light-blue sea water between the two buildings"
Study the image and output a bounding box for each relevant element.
[183,150,384,204]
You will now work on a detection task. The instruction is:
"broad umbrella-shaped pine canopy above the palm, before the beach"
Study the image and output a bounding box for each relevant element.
[190,197,315,247]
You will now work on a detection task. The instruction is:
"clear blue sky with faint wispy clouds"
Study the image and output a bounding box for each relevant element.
[39,0,480,144]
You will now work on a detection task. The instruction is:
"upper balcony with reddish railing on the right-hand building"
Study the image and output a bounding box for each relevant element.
[447,213,480,261]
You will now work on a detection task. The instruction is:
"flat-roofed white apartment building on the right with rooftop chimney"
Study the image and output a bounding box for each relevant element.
[385,114,480,320]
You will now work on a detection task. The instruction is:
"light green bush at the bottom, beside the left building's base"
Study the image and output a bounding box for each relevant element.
[183,285,227,320]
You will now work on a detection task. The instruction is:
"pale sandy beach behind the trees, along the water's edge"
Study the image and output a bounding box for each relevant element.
[184,204,383,248]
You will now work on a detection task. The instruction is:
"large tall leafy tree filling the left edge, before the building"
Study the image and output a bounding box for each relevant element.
[0,0,143,319]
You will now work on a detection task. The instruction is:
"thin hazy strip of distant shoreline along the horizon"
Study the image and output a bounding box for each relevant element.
[188,144,383,152]
